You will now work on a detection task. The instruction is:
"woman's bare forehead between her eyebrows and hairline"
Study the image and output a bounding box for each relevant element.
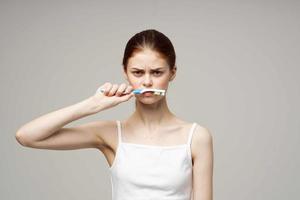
[127,49,168,69]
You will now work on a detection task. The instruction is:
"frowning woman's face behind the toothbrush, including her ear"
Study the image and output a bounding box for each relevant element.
[124,49,176,103]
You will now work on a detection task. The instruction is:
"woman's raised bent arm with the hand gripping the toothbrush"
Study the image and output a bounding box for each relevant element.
[16,82,134,150]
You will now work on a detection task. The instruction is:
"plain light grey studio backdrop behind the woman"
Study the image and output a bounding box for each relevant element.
[0,0,300,200]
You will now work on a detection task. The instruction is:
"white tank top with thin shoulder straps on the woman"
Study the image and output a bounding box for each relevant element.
[109,120,196,200]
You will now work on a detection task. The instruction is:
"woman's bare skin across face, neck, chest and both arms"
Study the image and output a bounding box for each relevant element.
[16,49,213,200]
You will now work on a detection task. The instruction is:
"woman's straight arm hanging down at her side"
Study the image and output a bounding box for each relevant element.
[192,127,214,200]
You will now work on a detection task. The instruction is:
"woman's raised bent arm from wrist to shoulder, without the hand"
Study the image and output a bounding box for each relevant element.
[16,98,104,149]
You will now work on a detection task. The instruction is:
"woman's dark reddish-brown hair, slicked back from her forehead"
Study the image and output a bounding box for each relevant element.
[122,29,176,72]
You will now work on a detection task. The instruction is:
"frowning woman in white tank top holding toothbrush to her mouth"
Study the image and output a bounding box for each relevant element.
[16,29,213,200]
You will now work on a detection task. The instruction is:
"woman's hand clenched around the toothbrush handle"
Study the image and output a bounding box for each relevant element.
[88,82,134,113]
